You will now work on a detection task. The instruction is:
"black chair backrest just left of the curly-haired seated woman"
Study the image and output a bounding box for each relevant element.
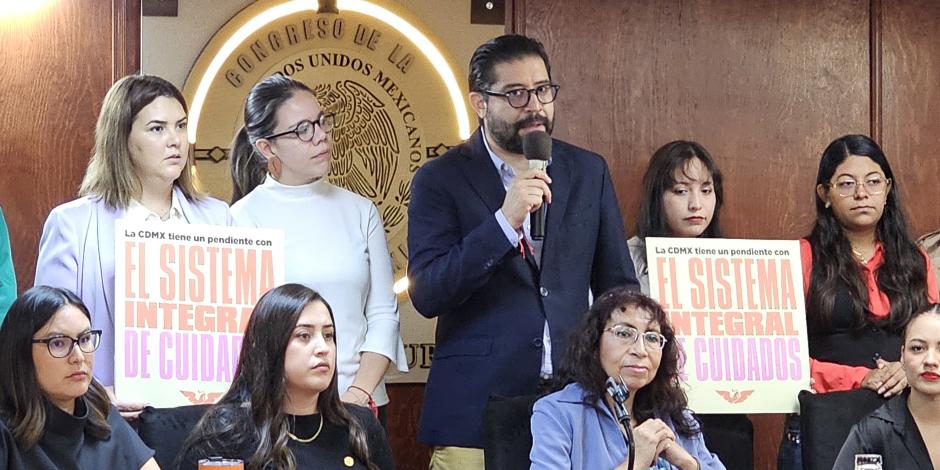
[483,395,539,470]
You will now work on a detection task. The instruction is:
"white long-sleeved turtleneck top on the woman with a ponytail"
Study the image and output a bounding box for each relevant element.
[232,177,408,406]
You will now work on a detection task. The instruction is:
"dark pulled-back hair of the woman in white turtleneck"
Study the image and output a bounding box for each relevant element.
[229,75,314,204]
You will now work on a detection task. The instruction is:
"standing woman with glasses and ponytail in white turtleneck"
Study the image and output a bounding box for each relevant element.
[231,75,408,423]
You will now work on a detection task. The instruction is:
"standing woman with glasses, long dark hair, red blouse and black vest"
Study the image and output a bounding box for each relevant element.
[778,135,940,469]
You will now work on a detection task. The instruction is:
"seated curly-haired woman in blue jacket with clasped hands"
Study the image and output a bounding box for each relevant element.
[530,288,725,470]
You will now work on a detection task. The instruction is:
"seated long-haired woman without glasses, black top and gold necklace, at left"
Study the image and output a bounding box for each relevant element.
[178,284,394,470]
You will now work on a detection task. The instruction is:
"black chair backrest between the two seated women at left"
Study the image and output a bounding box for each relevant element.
[137,405,210,469]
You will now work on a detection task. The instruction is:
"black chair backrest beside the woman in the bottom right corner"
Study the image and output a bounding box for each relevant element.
[799,389,885,470]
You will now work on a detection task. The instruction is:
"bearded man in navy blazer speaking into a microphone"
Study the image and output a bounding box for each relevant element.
[408,35,638,469]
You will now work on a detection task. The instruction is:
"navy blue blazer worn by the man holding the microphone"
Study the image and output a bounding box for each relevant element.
[408,130,639,447]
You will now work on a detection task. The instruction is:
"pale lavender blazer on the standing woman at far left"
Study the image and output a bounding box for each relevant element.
[34,187,232,385]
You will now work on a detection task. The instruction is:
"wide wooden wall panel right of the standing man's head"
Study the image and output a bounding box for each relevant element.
[512,0,872,469]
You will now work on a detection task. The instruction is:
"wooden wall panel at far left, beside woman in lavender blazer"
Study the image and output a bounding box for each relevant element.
[0,0,140,291]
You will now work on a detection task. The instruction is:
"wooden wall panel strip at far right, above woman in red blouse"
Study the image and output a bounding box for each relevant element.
[876,0,940,236]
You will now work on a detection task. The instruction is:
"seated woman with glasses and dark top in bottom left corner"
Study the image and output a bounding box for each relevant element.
[0,286,160,469]
